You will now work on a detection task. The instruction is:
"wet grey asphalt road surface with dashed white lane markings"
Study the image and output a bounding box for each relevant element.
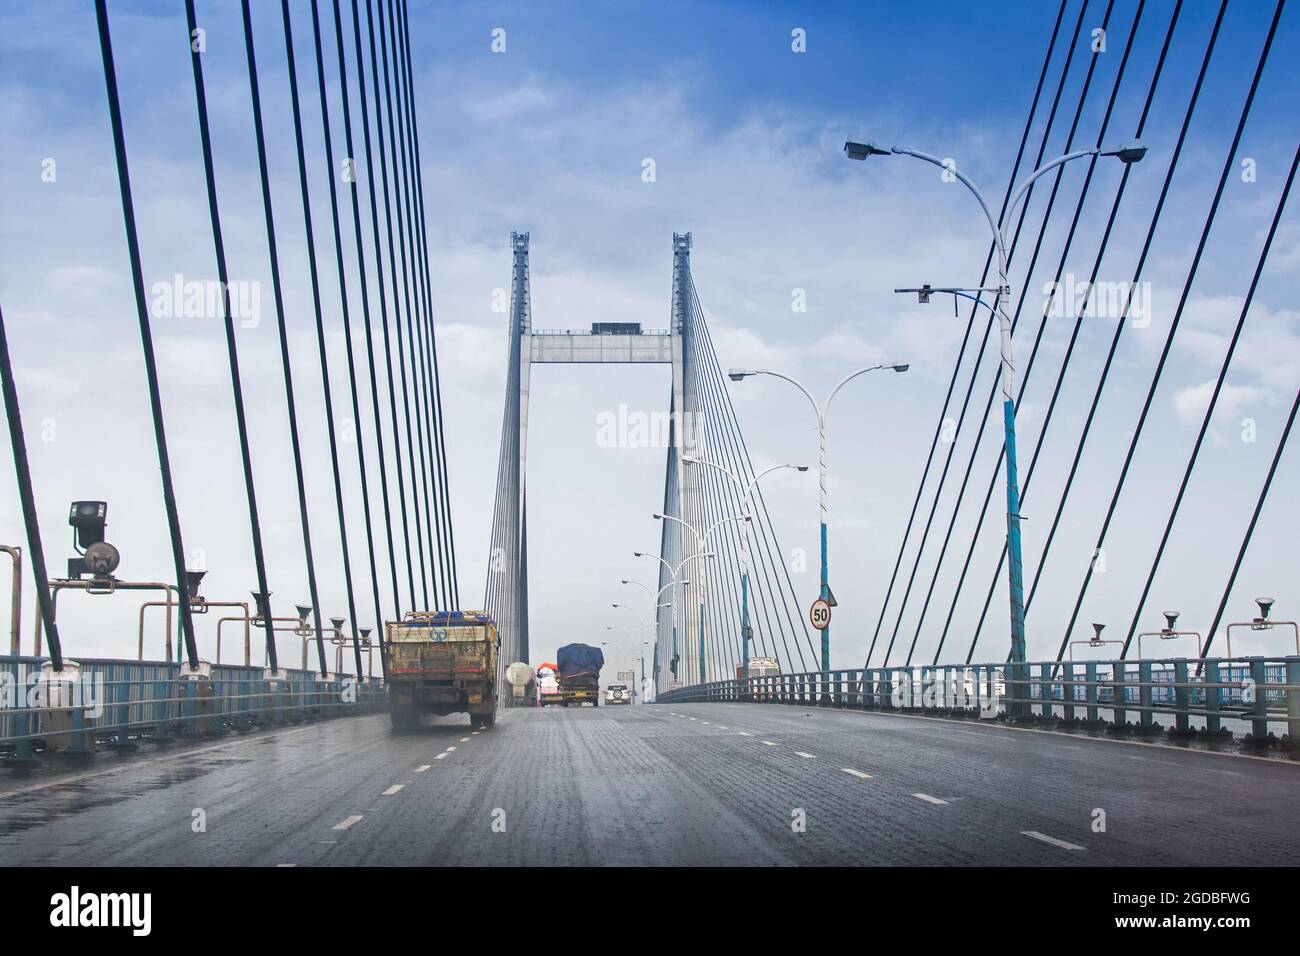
[0,704,1300,866]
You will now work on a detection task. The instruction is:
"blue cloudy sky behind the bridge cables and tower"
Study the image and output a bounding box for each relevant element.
[0,0,1300,681]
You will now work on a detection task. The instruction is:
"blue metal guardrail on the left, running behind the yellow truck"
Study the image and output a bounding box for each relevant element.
[0,656,387,765]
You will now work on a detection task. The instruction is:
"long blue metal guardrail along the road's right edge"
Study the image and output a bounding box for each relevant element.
[654,657,1300,747]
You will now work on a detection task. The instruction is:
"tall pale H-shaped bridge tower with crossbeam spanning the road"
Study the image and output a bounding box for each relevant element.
[484,232,719,688]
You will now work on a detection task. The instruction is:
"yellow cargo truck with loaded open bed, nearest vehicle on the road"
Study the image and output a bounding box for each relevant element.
[385,611,501,734]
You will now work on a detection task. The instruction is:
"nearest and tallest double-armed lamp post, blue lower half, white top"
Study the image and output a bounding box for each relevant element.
[844,140,1147,717]
